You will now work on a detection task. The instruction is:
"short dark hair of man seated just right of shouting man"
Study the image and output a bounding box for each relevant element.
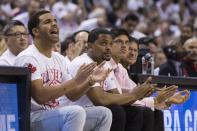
[88,28,111,43]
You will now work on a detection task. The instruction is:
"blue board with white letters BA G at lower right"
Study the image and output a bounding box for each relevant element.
[164,91,197,131]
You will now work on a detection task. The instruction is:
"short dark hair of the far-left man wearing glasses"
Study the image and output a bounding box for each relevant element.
[3,20,25,36]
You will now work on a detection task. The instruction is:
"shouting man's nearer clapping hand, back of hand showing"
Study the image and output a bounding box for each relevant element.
[74,62,96,84]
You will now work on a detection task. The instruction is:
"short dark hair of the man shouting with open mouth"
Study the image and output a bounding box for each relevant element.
[28,10,51,38]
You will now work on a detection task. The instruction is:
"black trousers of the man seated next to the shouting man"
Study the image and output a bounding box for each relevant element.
[108,105,143,131]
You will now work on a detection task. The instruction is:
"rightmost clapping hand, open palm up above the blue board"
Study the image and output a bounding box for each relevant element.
[166,90,190,104]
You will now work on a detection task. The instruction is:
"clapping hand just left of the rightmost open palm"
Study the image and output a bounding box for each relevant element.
[154,85,178,106]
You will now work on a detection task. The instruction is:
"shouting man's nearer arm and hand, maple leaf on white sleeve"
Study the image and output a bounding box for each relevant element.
[15,57,96,104]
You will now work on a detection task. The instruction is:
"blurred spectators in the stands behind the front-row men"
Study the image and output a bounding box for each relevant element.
[0,0,197,77]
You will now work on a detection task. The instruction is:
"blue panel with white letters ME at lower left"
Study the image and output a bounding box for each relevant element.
[0,83,19,131]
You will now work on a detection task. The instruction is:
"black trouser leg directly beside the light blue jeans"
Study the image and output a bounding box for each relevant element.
[107,105,126,131]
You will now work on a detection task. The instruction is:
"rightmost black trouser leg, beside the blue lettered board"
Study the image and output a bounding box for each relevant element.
[154,109,164,131]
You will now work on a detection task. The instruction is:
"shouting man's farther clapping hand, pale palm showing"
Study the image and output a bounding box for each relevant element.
[89,61,112,84]
